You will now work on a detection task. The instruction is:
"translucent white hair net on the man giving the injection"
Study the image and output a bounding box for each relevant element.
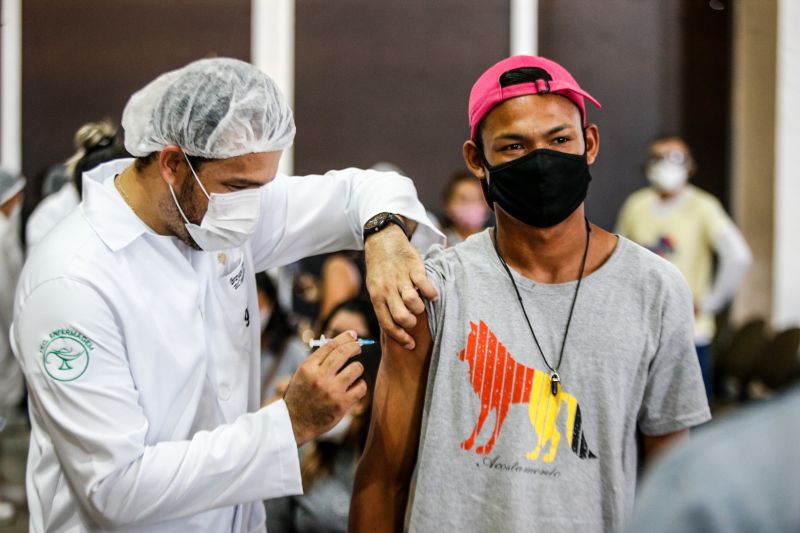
[122,58,295,159]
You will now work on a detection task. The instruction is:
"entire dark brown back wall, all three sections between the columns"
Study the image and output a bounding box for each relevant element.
[22,0,731,233]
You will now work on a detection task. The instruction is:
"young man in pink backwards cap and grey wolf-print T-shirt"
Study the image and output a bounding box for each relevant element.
[350,56,710,531]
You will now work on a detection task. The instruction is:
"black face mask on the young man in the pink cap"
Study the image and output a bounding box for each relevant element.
[481,149,592,228]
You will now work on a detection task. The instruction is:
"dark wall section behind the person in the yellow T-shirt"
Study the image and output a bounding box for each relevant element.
[539,0,731,228]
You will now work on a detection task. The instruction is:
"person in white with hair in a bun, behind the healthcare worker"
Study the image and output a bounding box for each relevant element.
[25,120,128,250]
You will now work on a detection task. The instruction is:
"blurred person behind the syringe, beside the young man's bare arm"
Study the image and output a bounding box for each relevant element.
[266,298,381,533]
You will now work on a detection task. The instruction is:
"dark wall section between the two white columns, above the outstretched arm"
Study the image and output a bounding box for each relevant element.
[295,0,509,209]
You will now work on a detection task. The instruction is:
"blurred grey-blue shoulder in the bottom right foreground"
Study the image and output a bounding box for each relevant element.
[625,387,800,533]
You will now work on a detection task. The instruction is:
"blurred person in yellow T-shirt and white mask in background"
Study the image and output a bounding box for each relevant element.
[617,136,752,399]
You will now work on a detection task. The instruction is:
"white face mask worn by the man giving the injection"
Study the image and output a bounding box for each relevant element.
[169,152,261,251]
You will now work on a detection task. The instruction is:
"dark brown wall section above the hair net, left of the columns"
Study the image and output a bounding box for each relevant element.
[22,0,250,216]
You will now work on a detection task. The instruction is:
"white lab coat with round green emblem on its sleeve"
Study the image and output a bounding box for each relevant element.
[12,156,441,533]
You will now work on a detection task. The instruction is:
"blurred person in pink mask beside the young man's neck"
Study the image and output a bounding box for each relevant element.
[442,170,491,246]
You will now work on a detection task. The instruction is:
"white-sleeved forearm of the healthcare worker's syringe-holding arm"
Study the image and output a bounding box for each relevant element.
[70,405,302,528]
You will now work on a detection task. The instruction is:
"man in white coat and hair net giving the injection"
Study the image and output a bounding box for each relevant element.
[12,58,442,533]
